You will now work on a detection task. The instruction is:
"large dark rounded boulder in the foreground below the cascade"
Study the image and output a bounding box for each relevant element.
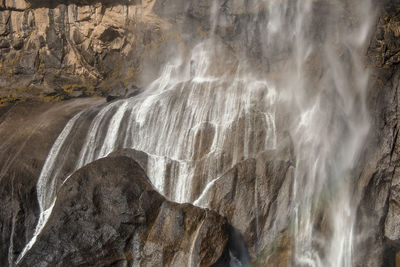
[20,157,228,266]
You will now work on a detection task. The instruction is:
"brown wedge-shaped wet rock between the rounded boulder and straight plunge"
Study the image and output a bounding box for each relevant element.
[194,147,293,260]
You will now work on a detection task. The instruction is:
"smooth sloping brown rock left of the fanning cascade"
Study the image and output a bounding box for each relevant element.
[0,98,104,266]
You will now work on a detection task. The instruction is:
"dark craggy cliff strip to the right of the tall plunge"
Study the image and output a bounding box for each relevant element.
[356,1,400,266]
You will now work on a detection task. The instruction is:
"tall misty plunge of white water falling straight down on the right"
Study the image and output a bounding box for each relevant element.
[284,1,372,267]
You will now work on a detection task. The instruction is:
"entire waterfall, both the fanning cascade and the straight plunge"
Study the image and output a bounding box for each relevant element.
[19,0,372,266]
